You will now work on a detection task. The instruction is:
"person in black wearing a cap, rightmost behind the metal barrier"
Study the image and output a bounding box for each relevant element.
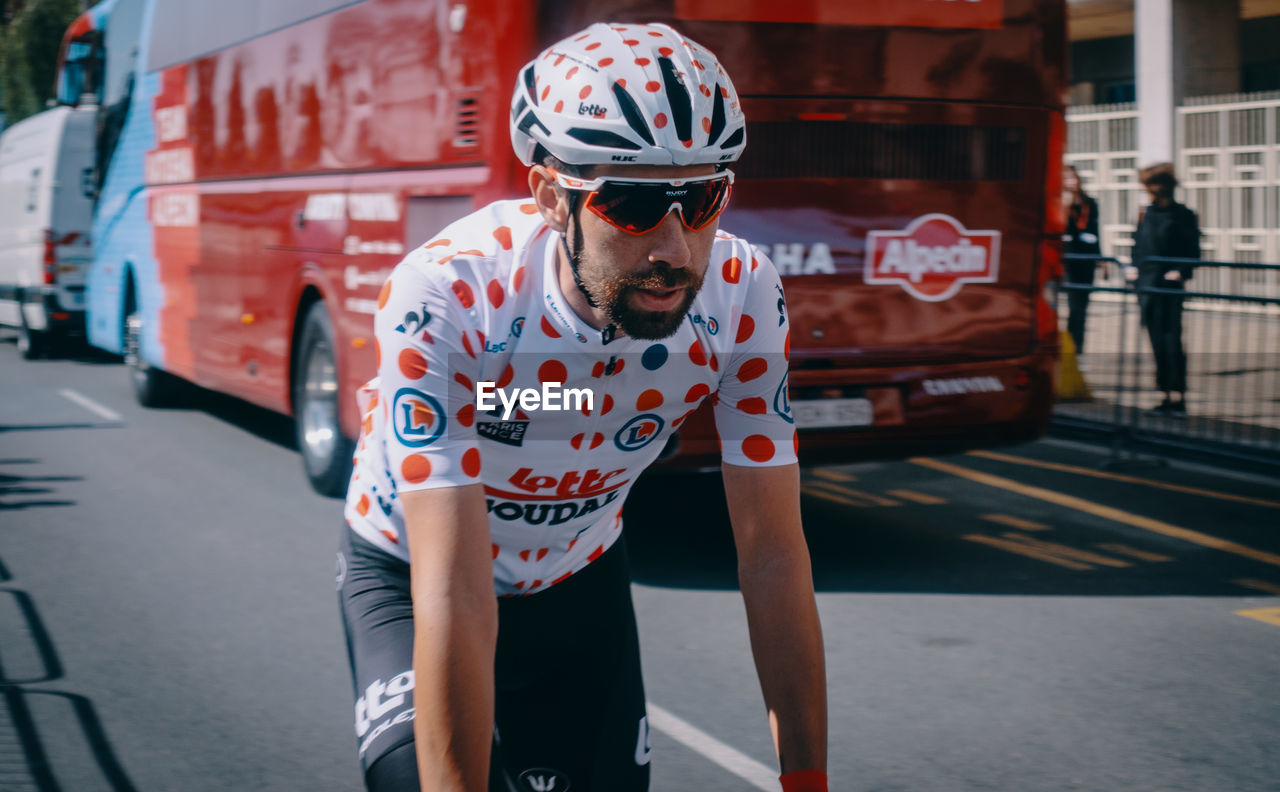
[1126,162,1201,416]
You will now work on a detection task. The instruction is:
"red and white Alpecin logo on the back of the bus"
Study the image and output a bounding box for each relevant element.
[863,212,1000,302]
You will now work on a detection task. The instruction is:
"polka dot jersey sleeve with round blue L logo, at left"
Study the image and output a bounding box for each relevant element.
[374,253,480,493]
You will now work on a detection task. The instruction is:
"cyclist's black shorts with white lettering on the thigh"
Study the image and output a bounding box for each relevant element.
[338,525,649,792]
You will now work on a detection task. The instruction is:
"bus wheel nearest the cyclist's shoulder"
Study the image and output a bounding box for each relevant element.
[293,302,355,496]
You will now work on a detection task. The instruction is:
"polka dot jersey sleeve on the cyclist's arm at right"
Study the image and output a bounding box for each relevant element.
[716,247,797,467]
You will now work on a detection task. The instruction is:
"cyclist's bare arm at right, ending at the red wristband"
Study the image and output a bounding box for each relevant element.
[722,464,827,774]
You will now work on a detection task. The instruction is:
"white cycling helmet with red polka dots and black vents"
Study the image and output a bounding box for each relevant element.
[511,23,746,165]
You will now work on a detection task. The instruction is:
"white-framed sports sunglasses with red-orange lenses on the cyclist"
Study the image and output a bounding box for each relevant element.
[552,170,733,235]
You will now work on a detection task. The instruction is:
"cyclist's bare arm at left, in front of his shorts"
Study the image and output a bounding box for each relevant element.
[401,484,498,792]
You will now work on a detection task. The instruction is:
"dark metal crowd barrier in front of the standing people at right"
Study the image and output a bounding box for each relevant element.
[1053,256,1280,471]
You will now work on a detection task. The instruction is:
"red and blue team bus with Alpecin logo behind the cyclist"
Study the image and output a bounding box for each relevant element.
[59,0,1066,493]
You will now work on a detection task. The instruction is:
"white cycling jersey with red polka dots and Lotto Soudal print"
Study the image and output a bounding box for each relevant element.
[346,201,796,595]
